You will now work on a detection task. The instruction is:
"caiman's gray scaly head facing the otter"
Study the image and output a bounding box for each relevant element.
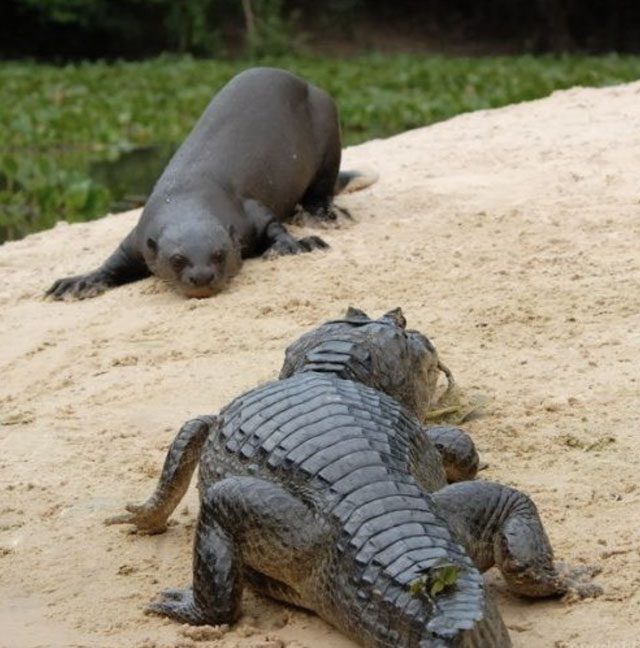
[280,307,453,419]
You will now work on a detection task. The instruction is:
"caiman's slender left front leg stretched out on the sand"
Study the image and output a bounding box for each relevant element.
[105,416,218,534]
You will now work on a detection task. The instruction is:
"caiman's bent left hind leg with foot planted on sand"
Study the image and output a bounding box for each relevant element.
[148,477,323,625]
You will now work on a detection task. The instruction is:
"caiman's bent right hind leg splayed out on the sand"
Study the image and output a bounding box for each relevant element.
[432,481,601,598]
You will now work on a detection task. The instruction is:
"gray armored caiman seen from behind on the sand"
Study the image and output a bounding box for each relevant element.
[108,309,600,648]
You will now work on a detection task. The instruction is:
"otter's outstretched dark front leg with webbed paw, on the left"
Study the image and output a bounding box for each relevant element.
[45,229,151,299]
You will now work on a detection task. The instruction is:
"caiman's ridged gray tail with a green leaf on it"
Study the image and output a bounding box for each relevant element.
[322,470,511,648]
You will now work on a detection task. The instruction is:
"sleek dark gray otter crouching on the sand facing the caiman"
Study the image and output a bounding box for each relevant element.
[47,68,374,299]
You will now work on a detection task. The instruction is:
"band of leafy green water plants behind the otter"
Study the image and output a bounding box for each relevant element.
[0,55,640,240]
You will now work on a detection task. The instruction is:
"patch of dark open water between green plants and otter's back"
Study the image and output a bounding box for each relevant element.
[90,144,177,212]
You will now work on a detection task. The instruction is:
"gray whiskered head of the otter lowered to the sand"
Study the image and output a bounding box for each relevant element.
[143,218,242,297]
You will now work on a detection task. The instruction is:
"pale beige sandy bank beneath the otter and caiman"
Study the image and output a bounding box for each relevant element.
[0,83,640,648]
